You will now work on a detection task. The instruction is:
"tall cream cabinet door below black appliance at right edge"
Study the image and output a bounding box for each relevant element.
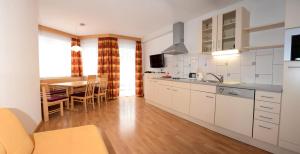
[279,62,300,152]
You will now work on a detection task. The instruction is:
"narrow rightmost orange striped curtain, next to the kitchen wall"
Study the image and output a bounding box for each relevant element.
[135,41,144,97]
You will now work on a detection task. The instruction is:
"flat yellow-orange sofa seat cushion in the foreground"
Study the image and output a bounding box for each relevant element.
[33,125,108,154]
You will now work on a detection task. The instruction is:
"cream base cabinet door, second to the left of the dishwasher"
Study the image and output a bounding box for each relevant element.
[171,88,190,114]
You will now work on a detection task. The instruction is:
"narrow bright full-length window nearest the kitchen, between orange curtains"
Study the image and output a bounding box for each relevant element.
[118,39,135,96]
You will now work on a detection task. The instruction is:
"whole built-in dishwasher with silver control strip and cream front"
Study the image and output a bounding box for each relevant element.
[215,86,255,137]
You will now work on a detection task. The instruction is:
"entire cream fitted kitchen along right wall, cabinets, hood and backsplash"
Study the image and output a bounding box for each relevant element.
[143,0,300,153]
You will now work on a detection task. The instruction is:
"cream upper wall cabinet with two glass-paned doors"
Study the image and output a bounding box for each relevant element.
[200,7,250,53]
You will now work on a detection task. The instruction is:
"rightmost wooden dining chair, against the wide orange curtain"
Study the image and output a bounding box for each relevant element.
[94,78,108,106]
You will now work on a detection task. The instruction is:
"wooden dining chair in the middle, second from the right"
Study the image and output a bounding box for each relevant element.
[71,79,95,112]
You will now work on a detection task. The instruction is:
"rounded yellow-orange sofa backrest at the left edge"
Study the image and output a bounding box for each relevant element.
[0,108,34,154]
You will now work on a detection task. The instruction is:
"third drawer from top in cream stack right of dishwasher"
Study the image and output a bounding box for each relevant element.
[254,110,279,124]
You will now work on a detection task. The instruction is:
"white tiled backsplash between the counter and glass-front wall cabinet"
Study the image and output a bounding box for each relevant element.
[164,48,283,85]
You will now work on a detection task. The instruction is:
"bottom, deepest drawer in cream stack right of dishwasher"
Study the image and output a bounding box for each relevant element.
[253,120,278,145]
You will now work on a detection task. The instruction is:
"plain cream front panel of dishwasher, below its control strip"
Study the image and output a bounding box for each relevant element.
[215,95,254,137]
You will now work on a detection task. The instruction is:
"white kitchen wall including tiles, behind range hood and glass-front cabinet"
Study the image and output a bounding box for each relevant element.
[143,0,285,84]
